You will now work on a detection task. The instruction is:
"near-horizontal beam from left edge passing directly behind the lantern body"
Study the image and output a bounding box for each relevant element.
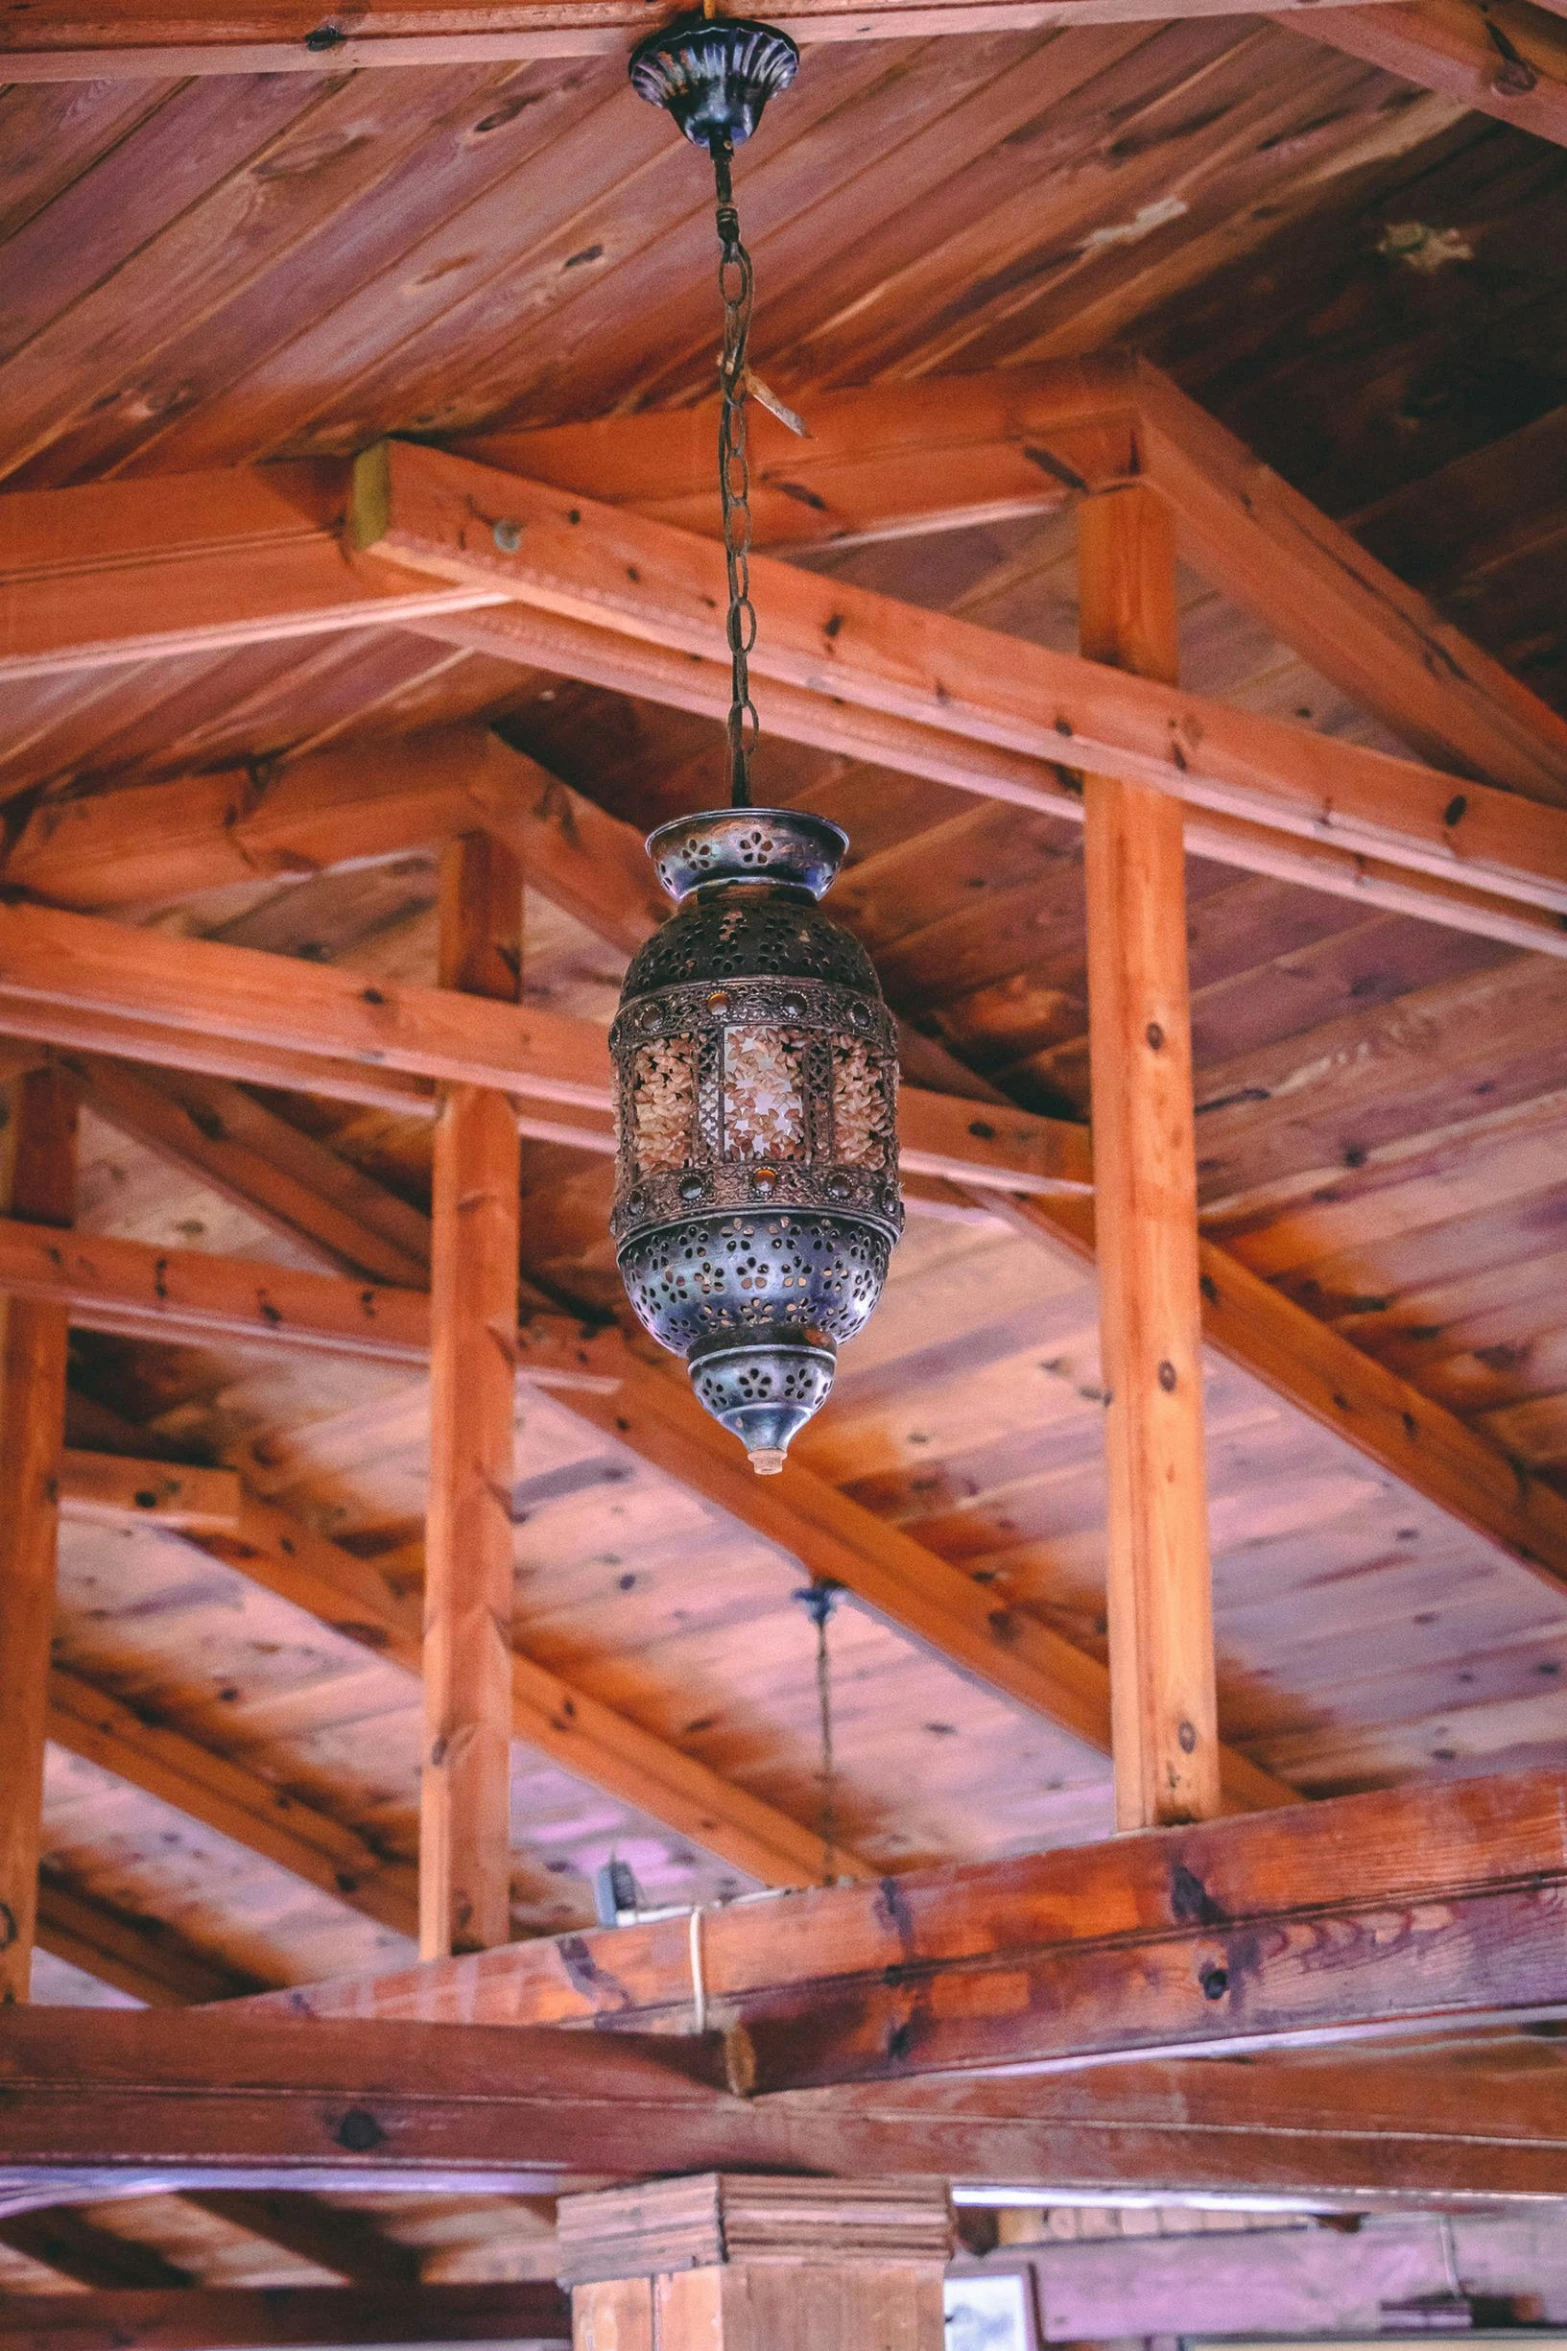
[0,898,1092,1194]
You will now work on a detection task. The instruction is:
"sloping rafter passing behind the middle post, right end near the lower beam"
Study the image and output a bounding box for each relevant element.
[49,1448,874,1890]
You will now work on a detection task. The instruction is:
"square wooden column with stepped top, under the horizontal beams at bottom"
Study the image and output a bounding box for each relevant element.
[559,2172,954,2351]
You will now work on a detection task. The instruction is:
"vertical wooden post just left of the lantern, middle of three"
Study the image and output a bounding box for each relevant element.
[418,832,522,1958]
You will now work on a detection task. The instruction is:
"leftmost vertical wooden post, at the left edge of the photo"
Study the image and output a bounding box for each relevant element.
[0,1070,75,2003]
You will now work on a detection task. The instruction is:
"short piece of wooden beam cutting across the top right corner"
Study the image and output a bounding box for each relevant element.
[1278,0,1567,146]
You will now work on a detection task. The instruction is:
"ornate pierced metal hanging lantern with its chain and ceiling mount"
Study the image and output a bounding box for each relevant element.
[608,16,902,1474]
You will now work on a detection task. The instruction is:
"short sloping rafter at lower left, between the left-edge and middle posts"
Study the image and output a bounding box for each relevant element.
[47,1664,418,1935]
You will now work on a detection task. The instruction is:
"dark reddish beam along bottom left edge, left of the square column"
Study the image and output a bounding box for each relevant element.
[0,2285,571,2351]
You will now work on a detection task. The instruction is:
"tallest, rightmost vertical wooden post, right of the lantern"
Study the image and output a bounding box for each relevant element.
[1078,487,1219,1829]
